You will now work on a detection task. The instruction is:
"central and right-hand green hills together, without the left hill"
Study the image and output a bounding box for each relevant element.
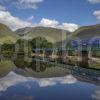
[16,24,100,47]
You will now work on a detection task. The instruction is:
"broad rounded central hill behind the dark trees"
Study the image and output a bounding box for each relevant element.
[15,27,69,43]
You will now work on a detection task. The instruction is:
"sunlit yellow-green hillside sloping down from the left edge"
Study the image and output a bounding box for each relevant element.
[0,23,19,44]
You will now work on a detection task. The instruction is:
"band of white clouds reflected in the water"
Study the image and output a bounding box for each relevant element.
[0,72,77,91]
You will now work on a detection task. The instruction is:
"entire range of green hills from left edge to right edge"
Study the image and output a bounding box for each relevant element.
[0,23,100,45]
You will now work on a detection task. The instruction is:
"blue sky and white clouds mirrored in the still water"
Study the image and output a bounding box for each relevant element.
[0,72,99,100]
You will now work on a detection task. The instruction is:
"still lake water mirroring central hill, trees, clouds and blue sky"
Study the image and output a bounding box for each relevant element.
[0,55,100,100]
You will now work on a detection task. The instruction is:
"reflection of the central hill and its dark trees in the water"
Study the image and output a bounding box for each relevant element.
[14,60,70,78]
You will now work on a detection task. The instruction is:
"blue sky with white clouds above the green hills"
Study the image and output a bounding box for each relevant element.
[0,0,100,32]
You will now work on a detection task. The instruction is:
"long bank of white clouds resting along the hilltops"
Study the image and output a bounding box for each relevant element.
[0,12,79,32]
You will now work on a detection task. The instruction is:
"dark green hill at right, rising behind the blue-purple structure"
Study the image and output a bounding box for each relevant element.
[71,24,100,39]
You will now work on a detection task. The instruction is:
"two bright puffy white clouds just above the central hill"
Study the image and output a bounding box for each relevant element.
[38,18,79,32]
